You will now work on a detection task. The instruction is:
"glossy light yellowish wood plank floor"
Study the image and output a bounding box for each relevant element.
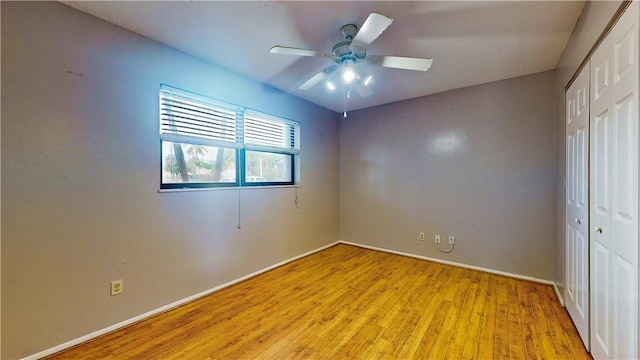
[50,245,590,359]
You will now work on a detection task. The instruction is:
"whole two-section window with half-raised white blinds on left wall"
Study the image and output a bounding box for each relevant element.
[160,85,300,189]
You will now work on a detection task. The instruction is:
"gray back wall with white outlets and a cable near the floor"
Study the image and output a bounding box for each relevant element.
[340,71,556,280]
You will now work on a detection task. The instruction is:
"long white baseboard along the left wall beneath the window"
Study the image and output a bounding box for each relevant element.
[22,241,339,360]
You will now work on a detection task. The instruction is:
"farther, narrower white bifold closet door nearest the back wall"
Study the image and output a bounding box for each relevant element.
[565,63,589,349]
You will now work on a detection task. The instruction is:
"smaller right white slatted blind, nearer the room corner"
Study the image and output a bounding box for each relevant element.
[244,111,300,154]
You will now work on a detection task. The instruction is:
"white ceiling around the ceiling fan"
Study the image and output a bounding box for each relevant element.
[63,1,584,112]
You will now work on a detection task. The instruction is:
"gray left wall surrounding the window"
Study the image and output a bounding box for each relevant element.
[1,2,339,359]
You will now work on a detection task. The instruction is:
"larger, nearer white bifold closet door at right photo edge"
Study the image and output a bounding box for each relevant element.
[590,1,639,359]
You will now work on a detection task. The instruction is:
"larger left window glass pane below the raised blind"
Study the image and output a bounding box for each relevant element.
[162,141,236,184]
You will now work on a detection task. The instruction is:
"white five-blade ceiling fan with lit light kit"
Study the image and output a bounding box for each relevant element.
[270,13,433,97]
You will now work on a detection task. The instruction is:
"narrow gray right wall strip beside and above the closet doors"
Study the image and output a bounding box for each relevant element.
[554,1,620,300]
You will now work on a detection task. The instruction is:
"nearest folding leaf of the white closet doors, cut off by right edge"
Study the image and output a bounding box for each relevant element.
[610,3,639,359]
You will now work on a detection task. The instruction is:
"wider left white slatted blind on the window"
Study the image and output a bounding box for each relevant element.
[160,86,242,148]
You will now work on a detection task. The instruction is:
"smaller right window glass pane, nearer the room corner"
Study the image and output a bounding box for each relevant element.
[245,150,293,183]
